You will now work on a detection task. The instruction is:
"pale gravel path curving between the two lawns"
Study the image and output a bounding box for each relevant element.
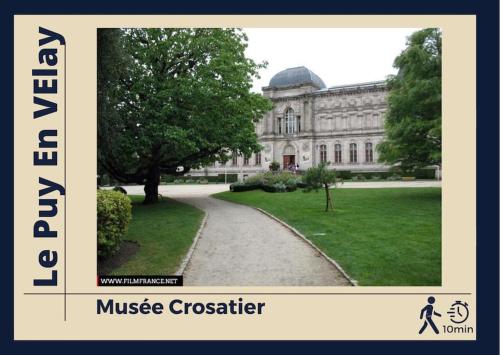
[175,196,350,286]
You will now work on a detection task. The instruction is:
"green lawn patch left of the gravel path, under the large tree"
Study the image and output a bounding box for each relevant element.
[112,196,203,275]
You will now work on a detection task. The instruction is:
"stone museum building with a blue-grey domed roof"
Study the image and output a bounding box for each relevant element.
[191,67,389,179]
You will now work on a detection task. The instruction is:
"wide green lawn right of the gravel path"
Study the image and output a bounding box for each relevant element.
[214,188,441,286]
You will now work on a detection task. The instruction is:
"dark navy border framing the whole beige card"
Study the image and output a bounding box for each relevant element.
[0,0,499,355]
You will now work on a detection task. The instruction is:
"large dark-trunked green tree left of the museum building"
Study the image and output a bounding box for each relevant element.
[98,28,271,203]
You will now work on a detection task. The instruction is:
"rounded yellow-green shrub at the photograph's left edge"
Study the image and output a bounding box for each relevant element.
[97,190,132,258]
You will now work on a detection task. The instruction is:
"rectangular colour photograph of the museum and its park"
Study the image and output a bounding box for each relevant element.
[96,27,442,287]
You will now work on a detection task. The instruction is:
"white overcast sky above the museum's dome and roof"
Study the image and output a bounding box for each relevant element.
[244,28,418,92]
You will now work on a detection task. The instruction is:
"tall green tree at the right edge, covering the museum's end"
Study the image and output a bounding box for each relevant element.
[378,28,441,171]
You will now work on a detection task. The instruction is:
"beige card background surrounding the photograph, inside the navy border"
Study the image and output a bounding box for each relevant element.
[14,16,476,339]
